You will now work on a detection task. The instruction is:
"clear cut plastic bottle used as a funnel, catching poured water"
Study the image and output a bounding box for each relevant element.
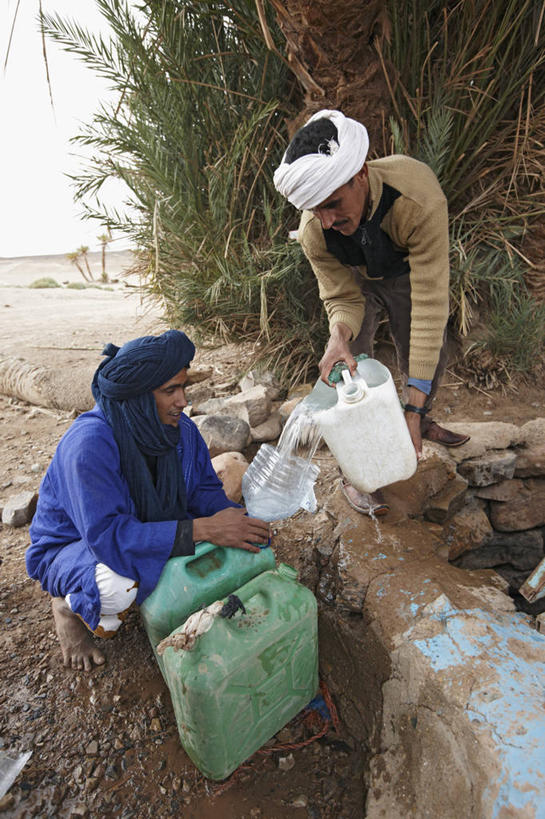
[242,444,320,521]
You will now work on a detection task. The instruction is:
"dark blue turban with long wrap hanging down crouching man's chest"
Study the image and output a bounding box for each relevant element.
[91,330,195,522]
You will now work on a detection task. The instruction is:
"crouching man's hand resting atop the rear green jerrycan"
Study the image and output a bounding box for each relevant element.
[193,506,270,552]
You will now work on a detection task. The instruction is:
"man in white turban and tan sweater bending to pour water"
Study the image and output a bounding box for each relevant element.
[274,110,469,514]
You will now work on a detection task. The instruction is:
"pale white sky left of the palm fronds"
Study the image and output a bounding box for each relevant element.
[0,0,133,257]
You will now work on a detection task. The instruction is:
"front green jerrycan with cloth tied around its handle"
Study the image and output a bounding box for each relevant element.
[159,563,318,779]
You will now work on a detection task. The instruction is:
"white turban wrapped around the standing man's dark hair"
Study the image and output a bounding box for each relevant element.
[273,109,369,210]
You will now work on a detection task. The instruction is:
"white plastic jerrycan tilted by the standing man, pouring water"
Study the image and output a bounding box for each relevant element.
[315,358,417,492]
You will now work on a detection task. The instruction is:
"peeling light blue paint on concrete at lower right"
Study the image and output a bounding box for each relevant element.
[405,594,545,819]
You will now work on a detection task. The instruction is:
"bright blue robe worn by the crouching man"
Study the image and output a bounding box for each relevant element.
[26,406,237,629]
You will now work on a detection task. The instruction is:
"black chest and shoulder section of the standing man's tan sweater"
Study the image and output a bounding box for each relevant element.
[323,184,410,279]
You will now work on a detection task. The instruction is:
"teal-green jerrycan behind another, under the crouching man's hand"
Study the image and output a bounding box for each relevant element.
[140,541,276,676]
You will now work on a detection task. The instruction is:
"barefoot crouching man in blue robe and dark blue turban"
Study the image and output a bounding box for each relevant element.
[26,330,269,670]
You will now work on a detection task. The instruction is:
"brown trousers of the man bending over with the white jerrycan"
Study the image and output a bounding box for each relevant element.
[350,272,447,409]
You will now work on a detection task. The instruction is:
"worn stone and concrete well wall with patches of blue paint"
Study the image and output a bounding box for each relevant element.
[296,419,545,819]
